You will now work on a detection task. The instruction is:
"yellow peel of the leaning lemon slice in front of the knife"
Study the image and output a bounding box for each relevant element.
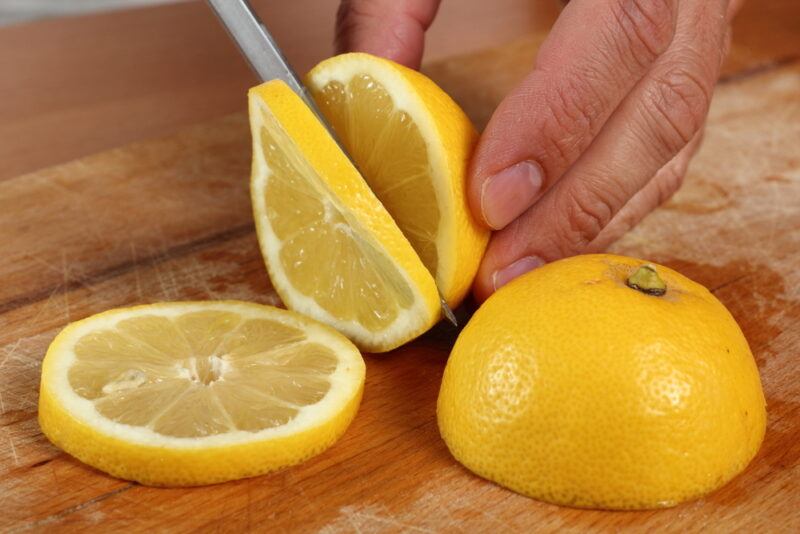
[248,80,441,352]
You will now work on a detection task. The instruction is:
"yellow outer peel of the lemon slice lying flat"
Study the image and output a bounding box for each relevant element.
[38,301,364,487]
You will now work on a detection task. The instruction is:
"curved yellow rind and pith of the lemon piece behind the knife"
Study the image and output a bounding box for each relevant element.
[306,52,490,308]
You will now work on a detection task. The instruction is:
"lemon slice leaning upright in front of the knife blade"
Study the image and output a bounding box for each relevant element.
[249,81,440,352]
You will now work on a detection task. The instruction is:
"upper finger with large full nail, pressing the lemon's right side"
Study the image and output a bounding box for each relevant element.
[468,0,678,229]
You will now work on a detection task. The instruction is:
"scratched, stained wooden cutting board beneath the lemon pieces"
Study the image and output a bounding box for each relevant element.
[0,0,800,532]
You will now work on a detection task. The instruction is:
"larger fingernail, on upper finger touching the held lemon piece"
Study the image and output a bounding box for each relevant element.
[481,161,543,230]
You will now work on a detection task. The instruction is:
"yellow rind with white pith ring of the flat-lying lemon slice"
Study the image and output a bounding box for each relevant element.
[38,301,365,486]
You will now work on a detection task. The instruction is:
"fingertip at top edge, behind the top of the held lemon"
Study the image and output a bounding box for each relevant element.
[336,0,439,69]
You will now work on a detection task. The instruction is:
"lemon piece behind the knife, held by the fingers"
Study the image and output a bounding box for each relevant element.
[307,53,489,308]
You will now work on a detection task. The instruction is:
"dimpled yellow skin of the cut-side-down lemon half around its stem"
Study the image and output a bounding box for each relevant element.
[438,255,766,509]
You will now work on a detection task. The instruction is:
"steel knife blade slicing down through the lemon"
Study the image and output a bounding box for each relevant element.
[206,0,458,326]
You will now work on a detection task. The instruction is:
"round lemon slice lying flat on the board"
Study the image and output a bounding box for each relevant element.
[39,301,364,486]
